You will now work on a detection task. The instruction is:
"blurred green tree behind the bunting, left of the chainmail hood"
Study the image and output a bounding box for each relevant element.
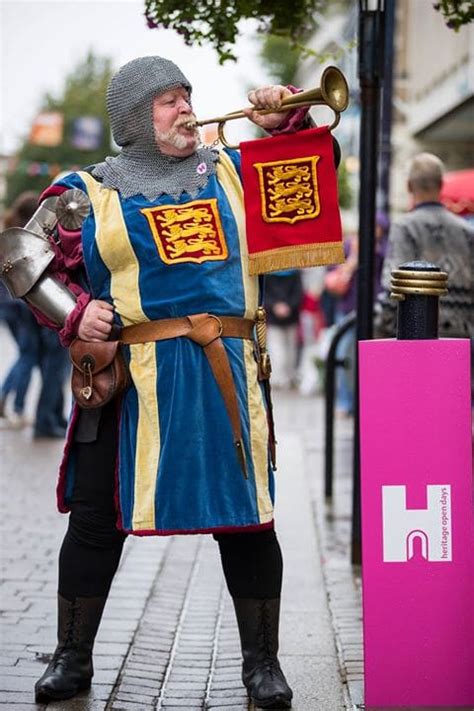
[7,53,112,205]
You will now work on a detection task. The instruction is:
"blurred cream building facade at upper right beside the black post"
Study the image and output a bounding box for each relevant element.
[392,0,474,210]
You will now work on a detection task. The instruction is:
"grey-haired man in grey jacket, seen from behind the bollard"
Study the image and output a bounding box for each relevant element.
[374,153,474,342]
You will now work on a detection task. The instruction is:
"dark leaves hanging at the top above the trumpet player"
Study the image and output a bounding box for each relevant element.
[145,0,322,64]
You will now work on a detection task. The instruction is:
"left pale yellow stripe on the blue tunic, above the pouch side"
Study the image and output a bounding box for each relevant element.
[78,171,160,530]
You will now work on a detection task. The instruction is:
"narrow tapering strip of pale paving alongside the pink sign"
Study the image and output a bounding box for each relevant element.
[278,395,364,711]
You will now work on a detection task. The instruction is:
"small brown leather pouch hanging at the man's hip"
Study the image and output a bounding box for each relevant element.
[69,338,130,409]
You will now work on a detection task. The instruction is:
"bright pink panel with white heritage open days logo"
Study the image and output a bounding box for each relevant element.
[359,339,474,708]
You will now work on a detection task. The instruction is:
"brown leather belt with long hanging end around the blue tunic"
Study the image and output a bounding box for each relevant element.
[119,313,255,479]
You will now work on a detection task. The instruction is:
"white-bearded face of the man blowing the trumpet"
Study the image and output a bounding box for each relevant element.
[153,87,199,158]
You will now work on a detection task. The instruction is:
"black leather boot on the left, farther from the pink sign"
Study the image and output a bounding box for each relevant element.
[35,595,107,701]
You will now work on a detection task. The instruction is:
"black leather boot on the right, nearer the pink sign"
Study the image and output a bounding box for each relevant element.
[234,598,293,709]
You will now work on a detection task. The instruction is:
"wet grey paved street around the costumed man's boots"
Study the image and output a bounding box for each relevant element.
[0,326,362,711]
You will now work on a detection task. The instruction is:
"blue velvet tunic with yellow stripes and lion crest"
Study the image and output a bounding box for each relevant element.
[59,151,273,535]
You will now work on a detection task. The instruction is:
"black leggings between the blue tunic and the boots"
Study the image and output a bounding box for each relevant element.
[59,405,283,600]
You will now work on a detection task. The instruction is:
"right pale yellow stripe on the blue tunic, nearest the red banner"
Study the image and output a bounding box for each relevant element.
[217,156,273,523]
